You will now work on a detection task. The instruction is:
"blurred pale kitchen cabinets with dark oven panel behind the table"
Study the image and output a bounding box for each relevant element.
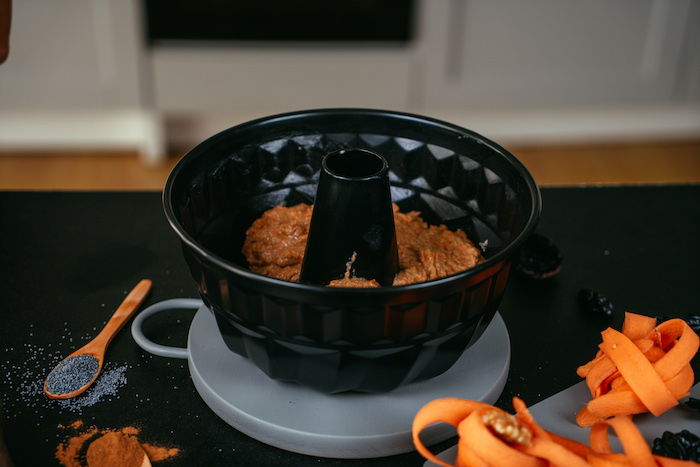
[0,0,700,164]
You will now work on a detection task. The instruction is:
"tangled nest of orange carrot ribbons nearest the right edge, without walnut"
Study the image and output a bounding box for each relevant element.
[576,313,700,427]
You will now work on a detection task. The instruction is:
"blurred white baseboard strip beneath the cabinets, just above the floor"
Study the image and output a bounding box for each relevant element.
[0,105,700,164]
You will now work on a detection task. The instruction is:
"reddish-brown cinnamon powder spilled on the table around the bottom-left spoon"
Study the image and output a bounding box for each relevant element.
[56,420,180,467]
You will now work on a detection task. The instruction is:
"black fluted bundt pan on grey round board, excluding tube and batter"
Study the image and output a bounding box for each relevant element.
[163,109,541,393]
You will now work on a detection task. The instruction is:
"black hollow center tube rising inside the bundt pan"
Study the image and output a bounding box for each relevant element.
[301,149,399,286]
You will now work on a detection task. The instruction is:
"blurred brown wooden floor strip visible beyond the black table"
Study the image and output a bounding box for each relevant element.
[0,139,700,190]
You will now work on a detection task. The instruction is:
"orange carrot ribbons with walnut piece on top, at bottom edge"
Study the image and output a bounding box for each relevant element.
[413,397,697,467]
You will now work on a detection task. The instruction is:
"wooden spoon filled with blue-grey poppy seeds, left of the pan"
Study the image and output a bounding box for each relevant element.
[44,279,151,399]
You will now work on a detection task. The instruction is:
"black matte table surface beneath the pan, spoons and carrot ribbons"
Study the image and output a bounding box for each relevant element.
[0,185,700,466]
